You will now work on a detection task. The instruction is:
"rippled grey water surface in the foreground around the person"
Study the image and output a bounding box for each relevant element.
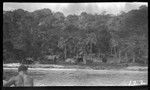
[4,68,148,86]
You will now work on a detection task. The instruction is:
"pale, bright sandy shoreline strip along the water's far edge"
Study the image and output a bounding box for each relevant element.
[3,64,148,71]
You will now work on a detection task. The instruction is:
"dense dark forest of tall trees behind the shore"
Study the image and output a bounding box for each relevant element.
[3,6,148,64]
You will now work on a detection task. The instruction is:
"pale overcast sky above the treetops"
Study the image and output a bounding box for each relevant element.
[3,2,148,15]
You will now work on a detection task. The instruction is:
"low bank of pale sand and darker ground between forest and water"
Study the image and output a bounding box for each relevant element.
[3,63,148,71]
